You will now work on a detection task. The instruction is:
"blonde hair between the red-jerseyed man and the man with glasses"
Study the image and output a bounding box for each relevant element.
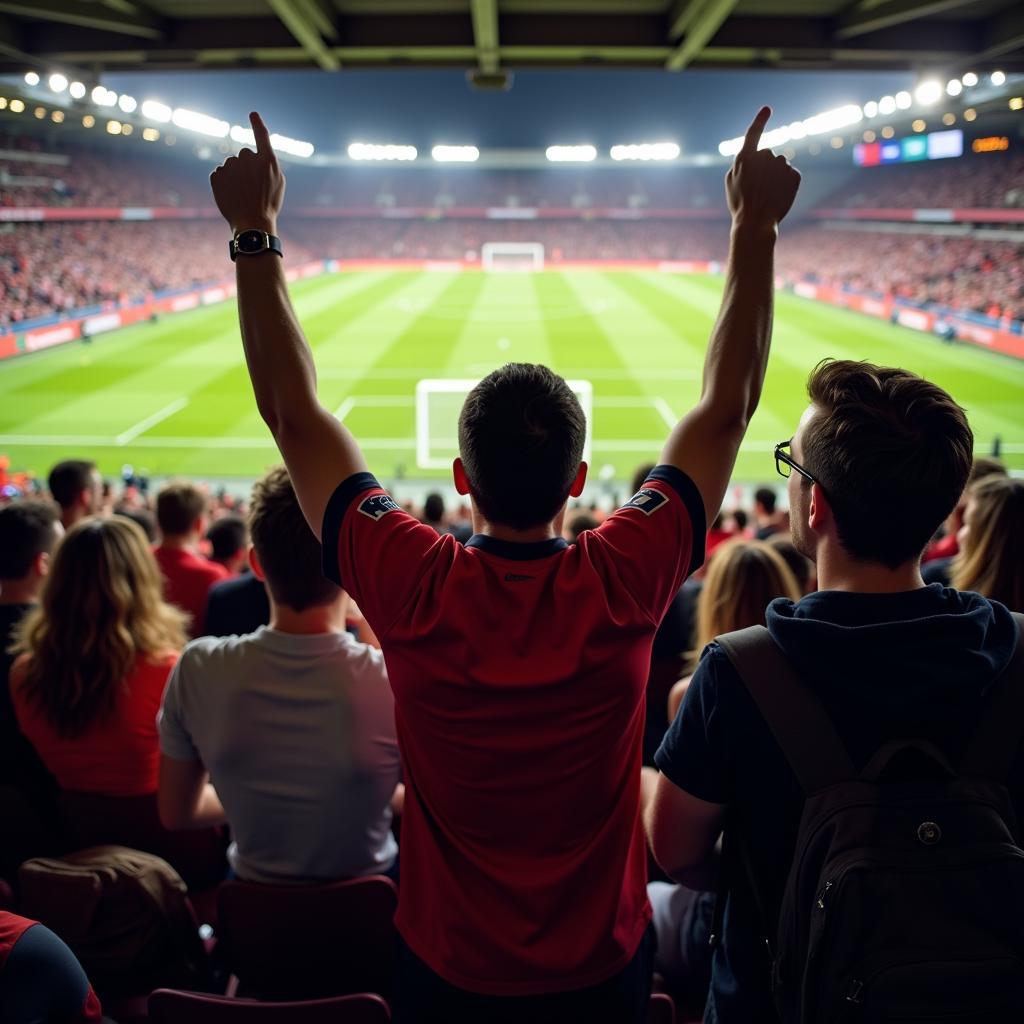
[694,538,802,656]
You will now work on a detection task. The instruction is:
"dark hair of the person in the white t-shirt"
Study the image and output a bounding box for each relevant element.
[249,466,340,611]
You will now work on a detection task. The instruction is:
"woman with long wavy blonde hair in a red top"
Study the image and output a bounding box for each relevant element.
[10,516,222,881]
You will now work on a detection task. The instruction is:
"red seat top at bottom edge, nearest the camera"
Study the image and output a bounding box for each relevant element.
[150,988,391,1024]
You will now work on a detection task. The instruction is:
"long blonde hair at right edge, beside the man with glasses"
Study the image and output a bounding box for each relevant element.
[950,476,1024,611]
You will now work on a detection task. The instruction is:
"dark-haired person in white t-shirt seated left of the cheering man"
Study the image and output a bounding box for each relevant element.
[159,467,400,883]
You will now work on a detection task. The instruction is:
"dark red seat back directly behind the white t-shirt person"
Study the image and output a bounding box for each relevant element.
[217,876,398,999]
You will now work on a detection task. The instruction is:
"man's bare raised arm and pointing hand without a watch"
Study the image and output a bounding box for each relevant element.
[662,106,800,523]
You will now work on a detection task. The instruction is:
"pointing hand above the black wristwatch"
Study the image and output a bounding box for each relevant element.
[210,113,285,234]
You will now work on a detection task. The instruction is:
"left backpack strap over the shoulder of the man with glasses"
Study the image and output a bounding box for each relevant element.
[715,626,856,795]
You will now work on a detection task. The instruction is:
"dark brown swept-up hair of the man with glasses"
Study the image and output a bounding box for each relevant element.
[801,359,974,568]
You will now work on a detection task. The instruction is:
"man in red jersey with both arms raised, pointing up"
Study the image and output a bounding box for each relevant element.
[211,108,800,1024]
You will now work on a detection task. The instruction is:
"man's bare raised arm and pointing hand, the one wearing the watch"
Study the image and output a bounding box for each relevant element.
[210,114,367,537]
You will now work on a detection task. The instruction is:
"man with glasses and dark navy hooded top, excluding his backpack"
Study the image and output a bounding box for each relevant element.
[646,360,1024,1024]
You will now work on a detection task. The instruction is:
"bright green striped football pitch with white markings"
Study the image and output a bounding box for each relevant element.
[0,270,1024,482]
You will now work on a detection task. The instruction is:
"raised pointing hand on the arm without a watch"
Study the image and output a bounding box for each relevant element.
[725,106,800,229]
